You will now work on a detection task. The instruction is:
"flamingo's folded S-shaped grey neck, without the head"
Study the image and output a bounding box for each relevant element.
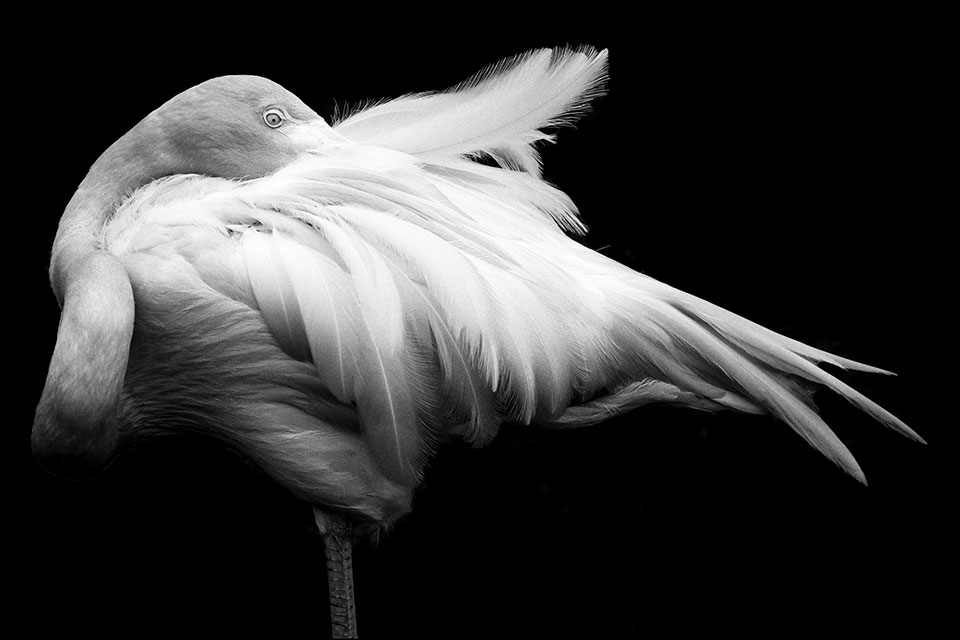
[32,132,156,477]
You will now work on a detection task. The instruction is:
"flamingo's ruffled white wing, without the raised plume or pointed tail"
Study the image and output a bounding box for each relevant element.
[108,147,593,482]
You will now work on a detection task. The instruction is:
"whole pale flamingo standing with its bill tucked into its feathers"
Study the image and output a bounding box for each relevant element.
[32,47,923,637]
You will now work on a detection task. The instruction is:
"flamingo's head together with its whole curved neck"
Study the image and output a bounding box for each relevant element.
[32,76,340,476]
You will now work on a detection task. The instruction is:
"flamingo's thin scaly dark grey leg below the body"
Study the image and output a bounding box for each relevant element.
[313,508,357,638]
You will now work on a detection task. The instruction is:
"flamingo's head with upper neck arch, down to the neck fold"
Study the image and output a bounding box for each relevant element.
[50,75,342,303]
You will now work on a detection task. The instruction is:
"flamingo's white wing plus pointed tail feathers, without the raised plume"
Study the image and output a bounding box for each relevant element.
[107,142,917,484]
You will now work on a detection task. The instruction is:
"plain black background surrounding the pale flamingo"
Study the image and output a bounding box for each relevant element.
[13,11,957,638]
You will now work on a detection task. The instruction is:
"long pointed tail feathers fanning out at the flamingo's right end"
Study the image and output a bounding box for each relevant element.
[552,276,923,483]
